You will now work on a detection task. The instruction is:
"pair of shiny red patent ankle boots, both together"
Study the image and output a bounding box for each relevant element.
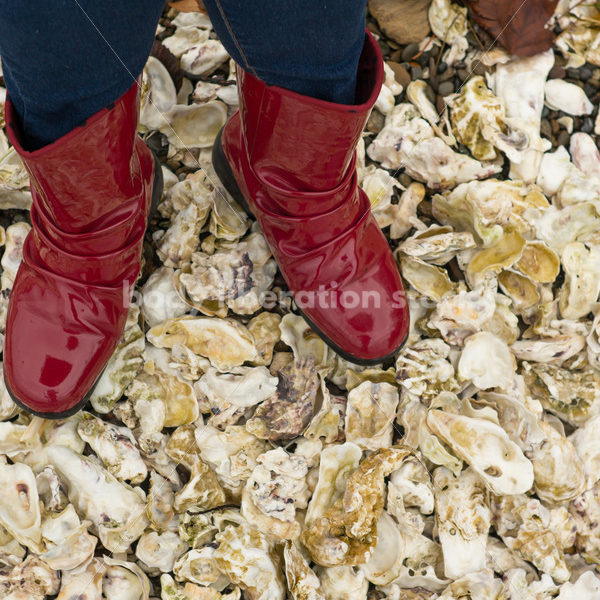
[4,35,408,418]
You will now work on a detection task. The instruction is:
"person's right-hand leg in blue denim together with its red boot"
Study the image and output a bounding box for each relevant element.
[212,0,409,364]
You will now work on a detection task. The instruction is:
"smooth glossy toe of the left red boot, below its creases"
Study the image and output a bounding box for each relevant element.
[4,263,124,418]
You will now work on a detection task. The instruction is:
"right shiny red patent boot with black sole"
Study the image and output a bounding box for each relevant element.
[213,34,409,364]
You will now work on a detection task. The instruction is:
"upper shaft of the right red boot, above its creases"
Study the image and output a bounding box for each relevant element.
[237,32,384,192]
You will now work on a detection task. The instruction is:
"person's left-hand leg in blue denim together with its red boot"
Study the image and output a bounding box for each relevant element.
[0,0,163,418]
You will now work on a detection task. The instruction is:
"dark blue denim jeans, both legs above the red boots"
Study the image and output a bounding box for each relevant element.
[0,0,366,149]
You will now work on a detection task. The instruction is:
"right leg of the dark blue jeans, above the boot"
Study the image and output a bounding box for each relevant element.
[204,0,367,104]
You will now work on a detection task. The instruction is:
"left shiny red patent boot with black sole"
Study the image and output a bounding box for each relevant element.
[4,83,162,418]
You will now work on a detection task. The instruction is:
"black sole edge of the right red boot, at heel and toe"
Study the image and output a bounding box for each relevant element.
[212,129,408,367]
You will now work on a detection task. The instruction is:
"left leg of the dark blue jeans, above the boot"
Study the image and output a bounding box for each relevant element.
[0,0,164,149]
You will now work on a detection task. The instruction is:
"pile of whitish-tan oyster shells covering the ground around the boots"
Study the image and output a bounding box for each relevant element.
[0,0,600,600]
